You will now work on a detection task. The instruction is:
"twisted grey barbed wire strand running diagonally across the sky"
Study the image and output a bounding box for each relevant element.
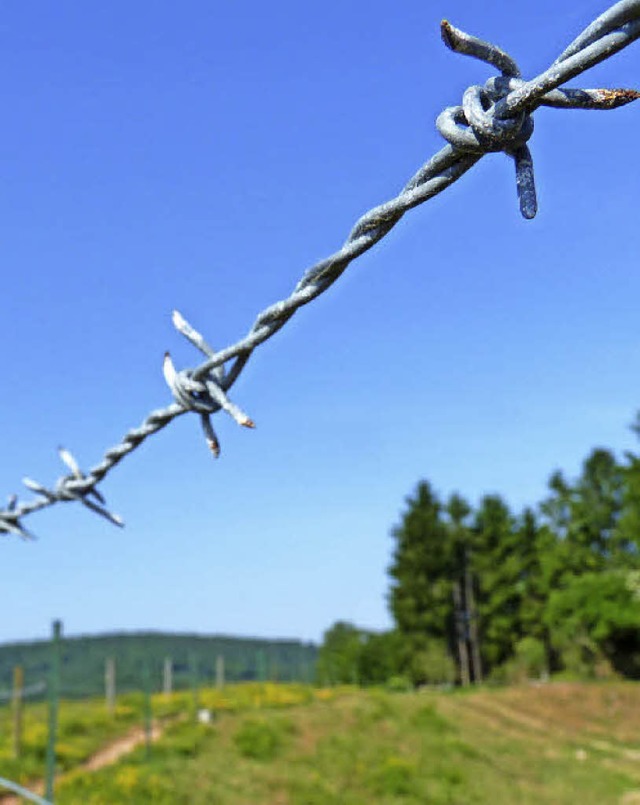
[0,0,640,538]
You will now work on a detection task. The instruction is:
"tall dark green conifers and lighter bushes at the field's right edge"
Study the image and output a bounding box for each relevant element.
[318,417,640,685]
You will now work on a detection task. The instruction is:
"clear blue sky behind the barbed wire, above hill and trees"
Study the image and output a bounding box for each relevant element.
[0,0,640,641]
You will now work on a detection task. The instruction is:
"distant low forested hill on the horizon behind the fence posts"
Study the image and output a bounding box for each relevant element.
[0,632,317,697]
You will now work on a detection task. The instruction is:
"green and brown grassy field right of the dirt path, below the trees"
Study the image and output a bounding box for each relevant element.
[6,683,640,805]
